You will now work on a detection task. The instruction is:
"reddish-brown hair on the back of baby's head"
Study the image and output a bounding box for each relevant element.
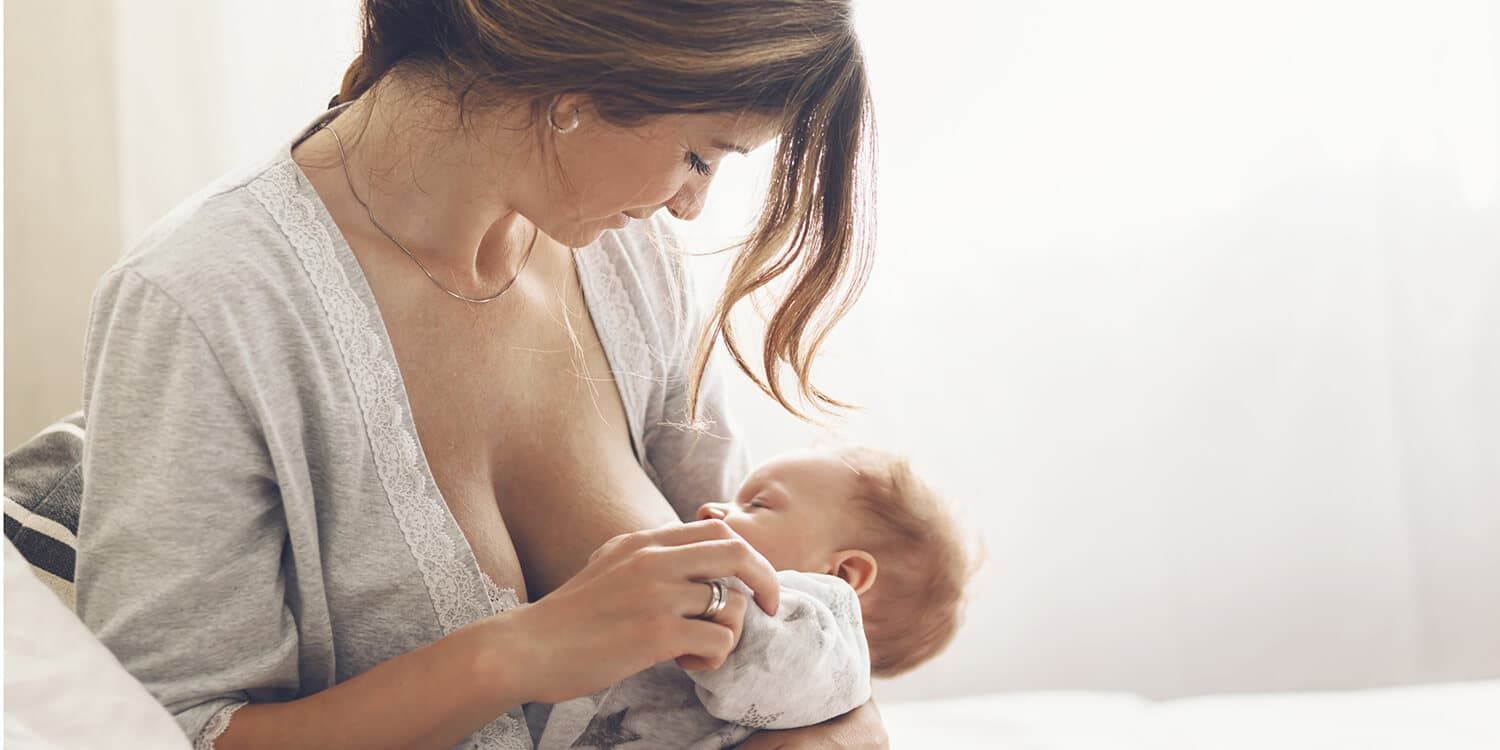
[839,447,974,677]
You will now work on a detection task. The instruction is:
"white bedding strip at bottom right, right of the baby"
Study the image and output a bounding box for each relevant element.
[881,681,1500,750]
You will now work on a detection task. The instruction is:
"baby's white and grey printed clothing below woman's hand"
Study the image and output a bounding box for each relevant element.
[537,570,870,750]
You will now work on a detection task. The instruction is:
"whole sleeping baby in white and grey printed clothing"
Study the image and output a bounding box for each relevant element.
[528,449,971,750]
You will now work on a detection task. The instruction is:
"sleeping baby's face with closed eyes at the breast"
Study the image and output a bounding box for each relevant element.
[698,453,858,573]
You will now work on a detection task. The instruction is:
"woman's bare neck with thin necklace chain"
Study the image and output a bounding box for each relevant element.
[293,75,537,286]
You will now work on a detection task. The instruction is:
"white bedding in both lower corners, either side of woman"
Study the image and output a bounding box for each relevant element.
[5,534,1500,750]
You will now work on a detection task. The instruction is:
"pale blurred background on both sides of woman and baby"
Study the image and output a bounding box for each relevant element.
[5,0,1500,699]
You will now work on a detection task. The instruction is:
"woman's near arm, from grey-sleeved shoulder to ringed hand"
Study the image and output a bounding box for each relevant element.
[78,267,779,749]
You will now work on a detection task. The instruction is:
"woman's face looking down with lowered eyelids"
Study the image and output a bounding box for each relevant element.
[534,98,776,248]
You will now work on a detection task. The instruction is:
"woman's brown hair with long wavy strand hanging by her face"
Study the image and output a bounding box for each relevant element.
[330,0,875,419]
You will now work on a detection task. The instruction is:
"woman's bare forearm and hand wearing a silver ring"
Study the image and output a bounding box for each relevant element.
[216,521,780,750]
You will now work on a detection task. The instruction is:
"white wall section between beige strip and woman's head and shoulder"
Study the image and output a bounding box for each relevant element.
[116,0,360,245]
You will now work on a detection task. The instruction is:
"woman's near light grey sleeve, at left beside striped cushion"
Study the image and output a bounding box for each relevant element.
[78,267,299,747]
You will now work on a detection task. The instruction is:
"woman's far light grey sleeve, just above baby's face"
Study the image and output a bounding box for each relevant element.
[645,240,750,521]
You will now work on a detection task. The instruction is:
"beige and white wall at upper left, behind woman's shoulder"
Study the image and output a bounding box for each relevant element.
[5,0,359,450]
